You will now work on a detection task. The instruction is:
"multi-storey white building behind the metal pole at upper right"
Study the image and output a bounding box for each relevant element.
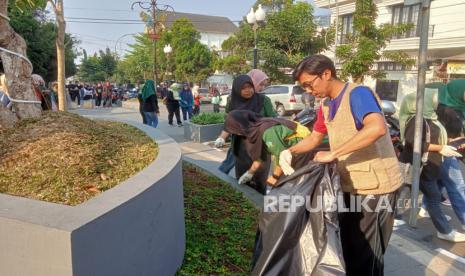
[315,0,465,103]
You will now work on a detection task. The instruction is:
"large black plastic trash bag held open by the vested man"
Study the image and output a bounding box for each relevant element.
[252,161,345,276]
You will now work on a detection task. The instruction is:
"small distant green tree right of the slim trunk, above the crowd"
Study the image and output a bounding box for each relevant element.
[78,48,117,82]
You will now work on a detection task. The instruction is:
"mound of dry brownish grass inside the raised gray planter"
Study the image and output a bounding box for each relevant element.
[0,112,158,205]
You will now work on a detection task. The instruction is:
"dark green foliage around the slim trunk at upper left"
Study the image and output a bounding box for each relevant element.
[8,3,78,82]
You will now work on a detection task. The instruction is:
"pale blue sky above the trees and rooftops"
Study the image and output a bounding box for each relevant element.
[64,0,327,60]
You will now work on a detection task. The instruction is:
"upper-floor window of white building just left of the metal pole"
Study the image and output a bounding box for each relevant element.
[392,4,421,38]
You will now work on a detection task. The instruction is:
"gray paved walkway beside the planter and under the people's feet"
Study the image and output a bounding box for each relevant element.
[72,105,465,276]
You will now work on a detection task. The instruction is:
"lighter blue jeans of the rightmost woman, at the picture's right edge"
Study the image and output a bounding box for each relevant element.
[440,157,465,225]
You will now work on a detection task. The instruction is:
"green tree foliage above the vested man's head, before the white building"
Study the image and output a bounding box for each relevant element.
[336,0,412,82]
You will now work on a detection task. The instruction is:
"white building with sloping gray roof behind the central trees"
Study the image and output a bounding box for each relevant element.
[165,12,237,50]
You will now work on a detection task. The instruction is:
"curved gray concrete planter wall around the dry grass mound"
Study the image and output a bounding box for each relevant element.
[0,119,185,276]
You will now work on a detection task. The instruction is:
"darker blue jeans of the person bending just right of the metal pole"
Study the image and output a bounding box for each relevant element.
[420,180,452,234]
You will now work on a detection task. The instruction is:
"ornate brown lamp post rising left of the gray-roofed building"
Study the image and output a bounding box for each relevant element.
[131,0,174,87]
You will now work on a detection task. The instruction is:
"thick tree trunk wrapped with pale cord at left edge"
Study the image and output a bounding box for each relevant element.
[0,0,42,126]
